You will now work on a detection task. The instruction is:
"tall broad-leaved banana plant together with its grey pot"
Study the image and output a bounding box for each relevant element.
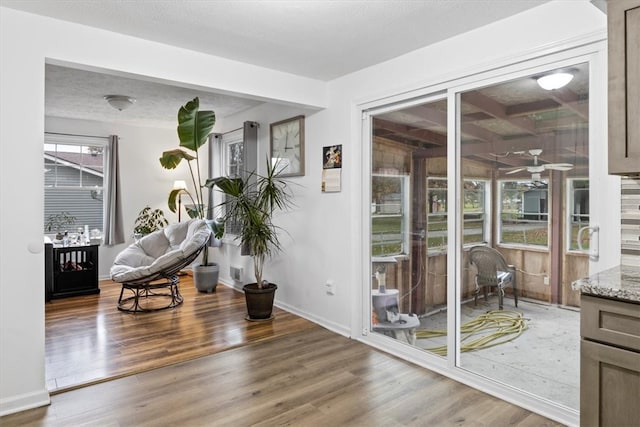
[160,97,221,292]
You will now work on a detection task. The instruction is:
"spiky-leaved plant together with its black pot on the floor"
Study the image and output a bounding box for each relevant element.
[206,159,291,320]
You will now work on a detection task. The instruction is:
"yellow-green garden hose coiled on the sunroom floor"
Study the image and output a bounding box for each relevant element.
[416,310,527,356]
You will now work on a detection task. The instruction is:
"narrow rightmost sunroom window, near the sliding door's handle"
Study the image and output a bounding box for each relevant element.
[566,178,589,251]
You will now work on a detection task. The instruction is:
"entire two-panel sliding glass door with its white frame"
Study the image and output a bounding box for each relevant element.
[365,45,619,413]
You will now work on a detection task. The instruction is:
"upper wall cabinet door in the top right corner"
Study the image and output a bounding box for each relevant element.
[607,0,640,175]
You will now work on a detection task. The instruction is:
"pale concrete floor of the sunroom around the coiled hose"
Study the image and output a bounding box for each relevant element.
[416,296,580,410]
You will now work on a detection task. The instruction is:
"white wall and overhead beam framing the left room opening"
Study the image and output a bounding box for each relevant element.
[0,7,327,415]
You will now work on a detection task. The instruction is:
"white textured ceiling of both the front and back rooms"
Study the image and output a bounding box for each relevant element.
[0,0,549,126]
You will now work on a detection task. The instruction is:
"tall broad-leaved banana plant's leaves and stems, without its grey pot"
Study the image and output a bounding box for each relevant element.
[160,97,222,265]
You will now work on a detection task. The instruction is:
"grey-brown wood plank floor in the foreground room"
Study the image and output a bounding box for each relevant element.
[0,326,558,427]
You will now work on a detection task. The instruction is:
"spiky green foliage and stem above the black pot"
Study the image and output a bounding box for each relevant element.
[205,159,292,289]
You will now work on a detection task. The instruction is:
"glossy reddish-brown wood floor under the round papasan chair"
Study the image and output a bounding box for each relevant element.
[45,275,313,392]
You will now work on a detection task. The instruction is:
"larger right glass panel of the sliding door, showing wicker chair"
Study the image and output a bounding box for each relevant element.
[458,63,589,409]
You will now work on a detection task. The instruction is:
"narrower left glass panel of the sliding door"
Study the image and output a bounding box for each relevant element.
[370,99,448,355]
